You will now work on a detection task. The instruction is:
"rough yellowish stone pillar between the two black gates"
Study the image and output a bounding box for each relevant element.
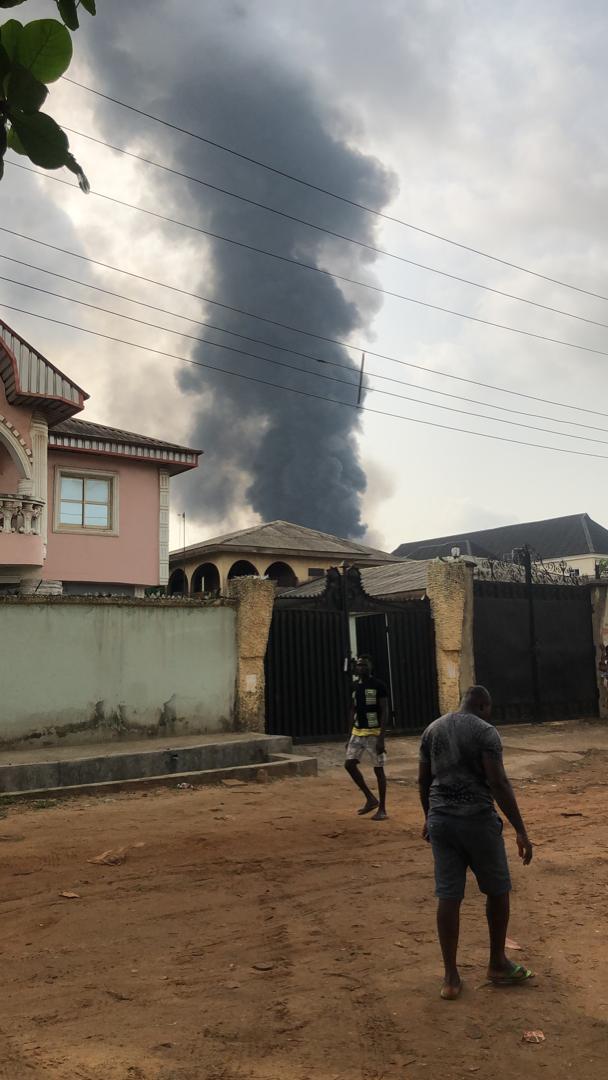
[427,558,475,713]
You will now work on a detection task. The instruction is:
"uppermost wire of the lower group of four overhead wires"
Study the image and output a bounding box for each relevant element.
[0,225,608,419]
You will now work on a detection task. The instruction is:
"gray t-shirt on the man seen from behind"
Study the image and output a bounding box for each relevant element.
[420,713,502,816]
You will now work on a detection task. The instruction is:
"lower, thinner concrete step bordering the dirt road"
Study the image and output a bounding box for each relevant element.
[0,754,317,806]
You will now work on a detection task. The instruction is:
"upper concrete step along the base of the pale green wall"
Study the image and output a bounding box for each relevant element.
[0,734,306,795]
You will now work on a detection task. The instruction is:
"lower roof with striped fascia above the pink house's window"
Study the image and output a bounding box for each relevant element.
[49,419,202,473]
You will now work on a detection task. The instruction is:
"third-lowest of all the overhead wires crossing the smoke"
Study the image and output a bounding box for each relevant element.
[0,252,608,434]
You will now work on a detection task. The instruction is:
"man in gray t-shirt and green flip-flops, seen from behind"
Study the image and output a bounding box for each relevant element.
[419,686,532,1000]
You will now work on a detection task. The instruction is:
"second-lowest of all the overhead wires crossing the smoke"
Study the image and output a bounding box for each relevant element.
[0,274,608,446]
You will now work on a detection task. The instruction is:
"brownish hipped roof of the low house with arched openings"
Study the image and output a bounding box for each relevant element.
[173,521,395,564]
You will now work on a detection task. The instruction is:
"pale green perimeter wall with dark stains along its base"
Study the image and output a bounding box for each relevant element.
[0,597,236,745]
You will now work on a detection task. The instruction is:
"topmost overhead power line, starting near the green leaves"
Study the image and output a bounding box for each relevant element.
[64,76,608,300]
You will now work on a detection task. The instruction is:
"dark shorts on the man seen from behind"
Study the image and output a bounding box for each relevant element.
[429,810,511,900]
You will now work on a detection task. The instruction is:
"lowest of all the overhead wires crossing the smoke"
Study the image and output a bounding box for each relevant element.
[0,301,608,461]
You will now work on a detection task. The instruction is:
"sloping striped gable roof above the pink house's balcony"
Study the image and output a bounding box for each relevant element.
[0,319,89,424]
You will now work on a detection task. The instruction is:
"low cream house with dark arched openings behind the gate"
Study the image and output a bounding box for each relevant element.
[168,522,398,596]
